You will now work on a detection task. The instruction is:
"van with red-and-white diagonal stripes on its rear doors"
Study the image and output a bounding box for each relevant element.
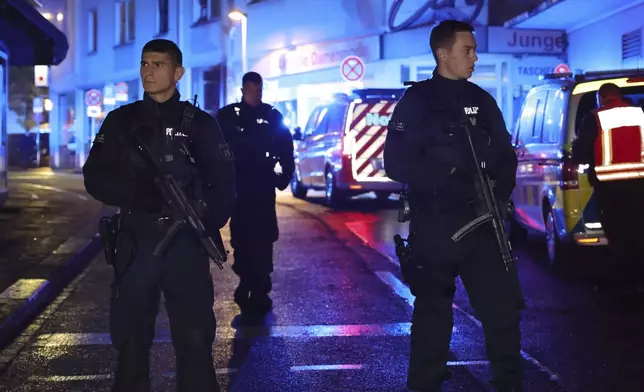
[291,89,404,207]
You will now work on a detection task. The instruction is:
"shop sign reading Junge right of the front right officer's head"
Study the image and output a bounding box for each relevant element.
[488,26,568,55]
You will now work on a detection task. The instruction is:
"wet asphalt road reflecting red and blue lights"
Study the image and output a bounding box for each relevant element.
[0,188,644,392]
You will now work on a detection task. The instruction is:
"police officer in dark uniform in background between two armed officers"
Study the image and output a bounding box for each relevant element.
[217,72,295,322]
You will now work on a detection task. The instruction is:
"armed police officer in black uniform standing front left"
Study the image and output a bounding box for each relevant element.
[83,39,235,392]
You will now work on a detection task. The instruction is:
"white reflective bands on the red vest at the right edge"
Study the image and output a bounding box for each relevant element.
[595,106,644,181]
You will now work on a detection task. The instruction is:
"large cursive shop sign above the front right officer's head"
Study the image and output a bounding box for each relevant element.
[387,0,488,32]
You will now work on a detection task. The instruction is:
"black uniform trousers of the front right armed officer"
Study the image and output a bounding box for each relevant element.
[407,208,525,391]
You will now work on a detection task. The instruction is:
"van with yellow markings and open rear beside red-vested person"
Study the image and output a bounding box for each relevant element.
[512,70,644,267]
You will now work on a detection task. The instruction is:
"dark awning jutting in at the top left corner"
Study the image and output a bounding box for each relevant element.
[0,0,69,66]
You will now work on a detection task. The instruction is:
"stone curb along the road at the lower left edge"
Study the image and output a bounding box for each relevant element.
[0,235,101,350]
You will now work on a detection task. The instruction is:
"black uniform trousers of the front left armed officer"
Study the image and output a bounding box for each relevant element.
[110,215,220,392]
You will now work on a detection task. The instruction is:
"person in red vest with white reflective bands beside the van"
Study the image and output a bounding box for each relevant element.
[572,83,644,291]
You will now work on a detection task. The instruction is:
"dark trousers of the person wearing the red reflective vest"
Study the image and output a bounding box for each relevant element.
[594,180,644,283]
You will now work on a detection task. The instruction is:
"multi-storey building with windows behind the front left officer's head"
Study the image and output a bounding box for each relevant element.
[50,0,236,168]
